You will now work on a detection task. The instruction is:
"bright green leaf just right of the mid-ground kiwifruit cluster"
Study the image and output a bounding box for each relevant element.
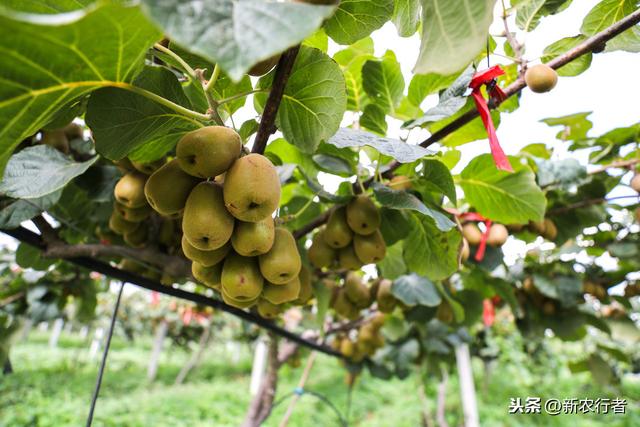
[404,214,462,280]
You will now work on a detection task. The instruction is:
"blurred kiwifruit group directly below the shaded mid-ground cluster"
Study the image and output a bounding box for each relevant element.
[325,272,398,320]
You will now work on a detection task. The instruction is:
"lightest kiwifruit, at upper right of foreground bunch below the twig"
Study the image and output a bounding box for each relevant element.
[224,154,280,222]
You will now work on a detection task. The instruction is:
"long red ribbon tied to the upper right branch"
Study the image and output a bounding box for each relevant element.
[469,65,513,172]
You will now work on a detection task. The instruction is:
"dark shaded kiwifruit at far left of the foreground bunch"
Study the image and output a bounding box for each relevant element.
[144,159,200,216]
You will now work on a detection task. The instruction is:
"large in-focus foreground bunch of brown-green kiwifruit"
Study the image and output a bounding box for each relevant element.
[110,126,311,318]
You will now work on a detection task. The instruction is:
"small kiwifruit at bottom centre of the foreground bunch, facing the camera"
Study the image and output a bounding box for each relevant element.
[222,253,264,301]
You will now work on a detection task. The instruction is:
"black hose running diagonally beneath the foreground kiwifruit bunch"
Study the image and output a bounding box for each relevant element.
[0,227,344,359]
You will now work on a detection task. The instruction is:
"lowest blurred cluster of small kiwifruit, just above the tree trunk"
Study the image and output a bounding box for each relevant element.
[331,313,384,362]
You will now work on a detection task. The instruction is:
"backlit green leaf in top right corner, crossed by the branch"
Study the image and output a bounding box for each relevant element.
[580,0,640,52]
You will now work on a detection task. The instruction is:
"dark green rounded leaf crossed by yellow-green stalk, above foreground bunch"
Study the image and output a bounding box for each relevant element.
[86,67,203,162]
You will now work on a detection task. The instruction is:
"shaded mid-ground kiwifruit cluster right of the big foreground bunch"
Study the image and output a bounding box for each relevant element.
[308,195,387,270]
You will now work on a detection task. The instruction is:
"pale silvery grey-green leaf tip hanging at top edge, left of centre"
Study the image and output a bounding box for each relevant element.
[142,0,335,81]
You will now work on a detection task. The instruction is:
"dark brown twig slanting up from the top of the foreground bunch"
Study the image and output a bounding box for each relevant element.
[251,45,300,154]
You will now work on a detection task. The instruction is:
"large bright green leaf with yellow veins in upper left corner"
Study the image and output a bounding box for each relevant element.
[0,5,161,176]
